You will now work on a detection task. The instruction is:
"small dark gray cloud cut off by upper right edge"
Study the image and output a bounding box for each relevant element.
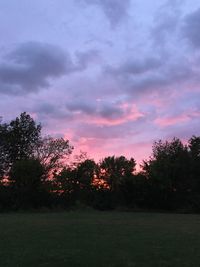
[182,8,200,48]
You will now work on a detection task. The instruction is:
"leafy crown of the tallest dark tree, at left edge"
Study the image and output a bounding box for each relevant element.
[0,112,41,181]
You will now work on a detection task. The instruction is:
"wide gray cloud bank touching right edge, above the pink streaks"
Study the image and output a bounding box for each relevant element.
[103,54,199,97]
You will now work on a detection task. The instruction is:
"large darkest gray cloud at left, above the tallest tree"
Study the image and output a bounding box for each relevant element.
[0,42,98,95]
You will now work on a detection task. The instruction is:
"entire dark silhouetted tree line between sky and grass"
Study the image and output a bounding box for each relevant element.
[0,112,200,212]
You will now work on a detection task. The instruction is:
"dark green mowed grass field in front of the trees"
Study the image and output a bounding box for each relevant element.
[0,211,200,267]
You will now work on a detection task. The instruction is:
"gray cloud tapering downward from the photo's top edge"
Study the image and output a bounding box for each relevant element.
[83,0,130,26]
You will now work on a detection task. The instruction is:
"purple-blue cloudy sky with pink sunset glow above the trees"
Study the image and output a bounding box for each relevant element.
[0,0,200,166]
